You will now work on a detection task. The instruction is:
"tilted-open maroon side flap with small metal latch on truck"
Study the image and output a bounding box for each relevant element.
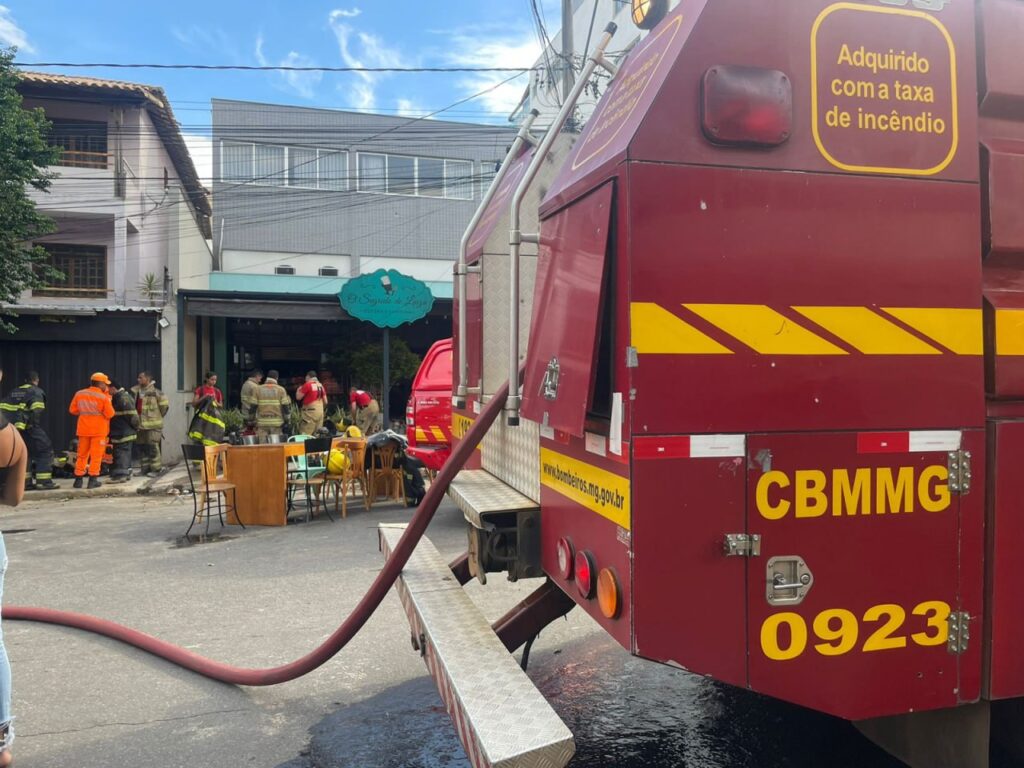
[522,181,613,437]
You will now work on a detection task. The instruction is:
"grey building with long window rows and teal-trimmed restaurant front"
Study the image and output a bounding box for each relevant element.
[184,99,514,411]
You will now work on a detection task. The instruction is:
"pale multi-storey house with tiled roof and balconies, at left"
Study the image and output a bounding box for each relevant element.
[0,72,212,454]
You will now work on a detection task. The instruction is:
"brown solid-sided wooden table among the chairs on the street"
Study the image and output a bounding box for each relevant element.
[224,442,305,525]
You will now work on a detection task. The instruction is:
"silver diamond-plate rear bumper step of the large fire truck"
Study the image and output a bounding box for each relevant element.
[379,525,575,768]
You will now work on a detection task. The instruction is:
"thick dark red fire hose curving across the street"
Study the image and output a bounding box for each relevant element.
[3,384,508,685]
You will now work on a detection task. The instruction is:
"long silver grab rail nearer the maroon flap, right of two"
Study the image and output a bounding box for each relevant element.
[503,24,618,427]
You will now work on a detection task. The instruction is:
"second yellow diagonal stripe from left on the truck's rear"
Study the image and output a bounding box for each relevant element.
[683,304,847,354]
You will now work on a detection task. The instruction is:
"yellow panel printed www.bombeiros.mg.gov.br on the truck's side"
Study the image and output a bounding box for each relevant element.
[541,447,630,530]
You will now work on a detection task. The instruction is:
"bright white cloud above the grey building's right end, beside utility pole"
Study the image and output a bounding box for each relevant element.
[445,29,541,117]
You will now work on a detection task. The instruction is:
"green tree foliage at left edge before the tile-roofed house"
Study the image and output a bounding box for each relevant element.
[0,48,61,331]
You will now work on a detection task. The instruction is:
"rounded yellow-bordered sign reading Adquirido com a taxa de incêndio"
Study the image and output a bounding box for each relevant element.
[811,2,959,176]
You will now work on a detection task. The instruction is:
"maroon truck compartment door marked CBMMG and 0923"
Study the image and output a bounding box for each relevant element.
[748,431,981,720]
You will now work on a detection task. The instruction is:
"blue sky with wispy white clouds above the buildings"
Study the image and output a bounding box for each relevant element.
[0,0,560,179]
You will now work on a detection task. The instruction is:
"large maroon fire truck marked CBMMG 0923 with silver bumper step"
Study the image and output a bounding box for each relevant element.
[382,0,1024,766]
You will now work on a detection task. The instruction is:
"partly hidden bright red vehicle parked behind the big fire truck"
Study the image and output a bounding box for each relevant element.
[406,339,452,472]
